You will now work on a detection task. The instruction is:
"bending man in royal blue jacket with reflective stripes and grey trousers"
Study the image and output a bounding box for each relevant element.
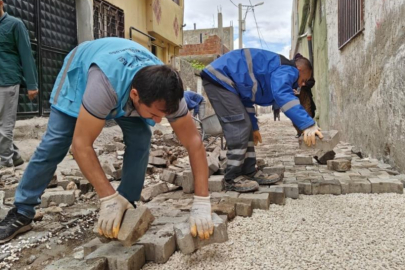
[201,49,323,192]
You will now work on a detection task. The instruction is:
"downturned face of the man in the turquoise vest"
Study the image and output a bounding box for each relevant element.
[130,89,166,123]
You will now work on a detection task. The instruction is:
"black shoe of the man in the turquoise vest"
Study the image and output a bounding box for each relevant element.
[0,208,32,244]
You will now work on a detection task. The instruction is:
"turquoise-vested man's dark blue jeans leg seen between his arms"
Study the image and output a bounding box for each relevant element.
[115,117,152,203]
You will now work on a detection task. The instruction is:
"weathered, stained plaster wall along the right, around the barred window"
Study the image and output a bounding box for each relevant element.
[326,0,405,170]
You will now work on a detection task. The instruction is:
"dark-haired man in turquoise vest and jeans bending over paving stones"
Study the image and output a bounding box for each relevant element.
[0,38,213,244]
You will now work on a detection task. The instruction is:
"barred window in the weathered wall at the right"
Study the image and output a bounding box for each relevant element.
[338,0,364,49]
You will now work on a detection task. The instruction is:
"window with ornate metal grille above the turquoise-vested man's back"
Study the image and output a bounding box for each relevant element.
[93,0,125,39]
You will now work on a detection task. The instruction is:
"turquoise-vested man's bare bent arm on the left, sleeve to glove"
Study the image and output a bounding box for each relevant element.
[72,106,115,198]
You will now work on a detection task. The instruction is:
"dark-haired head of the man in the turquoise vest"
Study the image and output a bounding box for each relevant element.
[130,66,184,123]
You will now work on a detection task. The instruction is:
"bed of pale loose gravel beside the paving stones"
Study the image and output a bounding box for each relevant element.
[143,194,405,270]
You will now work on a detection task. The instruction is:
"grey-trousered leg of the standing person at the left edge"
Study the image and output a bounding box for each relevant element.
[0,85,20,167]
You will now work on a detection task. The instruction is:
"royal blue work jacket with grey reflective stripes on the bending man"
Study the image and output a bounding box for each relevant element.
[201,49,315,130]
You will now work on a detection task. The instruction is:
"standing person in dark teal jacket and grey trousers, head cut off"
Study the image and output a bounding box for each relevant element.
[0,0,38,169]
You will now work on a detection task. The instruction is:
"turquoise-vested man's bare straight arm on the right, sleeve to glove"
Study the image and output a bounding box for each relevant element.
[170,113,209,197]
